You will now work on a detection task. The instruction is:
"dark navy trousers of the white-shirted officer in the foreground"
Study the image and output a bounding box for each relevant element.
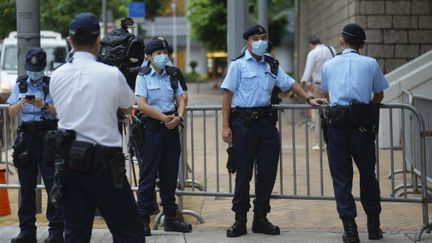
[63,164,145,243]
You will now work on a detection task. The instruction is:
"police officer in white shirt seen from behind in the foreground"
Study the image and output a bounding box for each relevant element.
[50,13,145,243]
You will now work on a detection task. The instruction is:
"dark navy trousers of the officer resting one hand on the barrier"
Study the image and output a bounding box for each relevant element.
[231,118,280,216]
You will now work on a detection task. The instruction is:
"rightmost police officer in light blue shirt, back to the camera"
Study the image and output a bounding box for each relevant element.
[321,24,389,243]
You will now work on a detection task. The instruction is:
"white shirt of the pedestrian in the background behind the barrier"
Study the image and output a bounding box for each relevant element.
[301,44,336,82]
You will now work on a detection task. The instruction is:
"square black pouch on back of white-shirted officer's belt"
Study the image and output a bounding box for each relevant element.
[68,141,94,173]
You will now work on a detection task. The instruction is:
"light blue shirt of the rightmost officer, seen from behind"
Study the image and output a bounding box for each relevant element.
[320,49,389,106]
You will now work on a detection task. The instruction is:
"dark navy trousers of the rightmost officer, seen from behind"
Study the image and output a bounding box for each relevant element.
[327,126,381,219]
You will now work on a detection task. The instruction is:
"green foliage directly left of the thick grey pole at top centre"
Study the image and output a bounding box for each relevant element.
[186,0,227,50]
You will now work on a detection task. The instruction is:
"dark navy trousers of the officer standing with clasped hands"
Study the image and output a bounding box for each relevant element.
[138,126,181,219]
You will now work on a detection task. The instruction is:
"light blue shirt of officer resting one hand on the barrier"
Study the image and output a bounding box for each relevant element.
[221,50,295,107]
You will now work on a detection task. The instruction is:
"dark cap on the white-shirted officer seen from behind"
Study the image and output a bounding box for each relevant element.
[69,13,100,35]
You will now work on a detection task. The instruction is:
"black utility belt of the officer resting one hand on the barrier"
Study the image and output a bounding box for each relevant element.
[231,106,278,126]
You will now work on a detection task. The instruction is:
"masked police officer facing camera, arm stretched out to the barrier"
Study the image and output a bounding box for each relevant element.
[221,25,325,237]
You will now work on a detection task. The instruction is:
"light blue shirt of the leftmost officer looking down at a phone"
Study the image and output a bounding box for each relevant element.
[7,78,56,122]
